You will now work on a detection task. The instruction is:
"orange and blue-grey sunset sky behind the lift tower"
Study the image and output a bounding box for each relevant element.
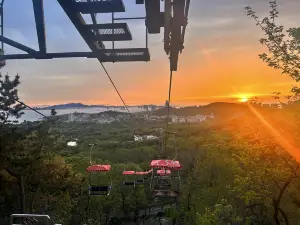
[1,0,300,106]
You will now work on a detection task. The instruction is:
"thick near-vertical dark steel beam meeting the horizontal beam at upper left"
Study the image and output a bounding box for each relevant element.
[32,0,46,53]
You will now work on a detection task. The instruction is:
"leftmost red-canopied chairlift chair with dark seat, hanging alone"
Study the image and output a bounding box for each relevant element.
[86,165,112,196]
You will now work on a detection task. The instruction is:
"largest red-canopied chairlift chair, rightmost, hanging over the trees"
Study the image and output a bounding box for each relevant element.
[150,160,182,198]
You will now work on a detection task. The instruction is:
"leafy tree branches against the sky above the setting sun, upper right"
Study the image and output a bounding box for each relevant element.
[245,0,300,99]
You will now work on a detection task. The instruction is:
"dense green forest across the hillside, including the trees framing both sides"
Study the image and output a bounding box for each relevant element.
[0,1,300,225]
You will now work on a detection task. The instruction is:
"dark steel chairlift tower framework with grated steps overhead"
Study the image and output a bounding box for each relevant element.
[0,0,190,71]
